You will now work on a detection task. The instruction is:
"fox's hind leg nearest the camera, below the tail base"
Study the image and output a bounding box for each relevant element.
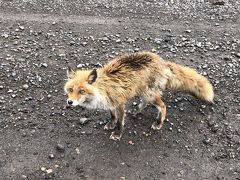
[151,95,167,130]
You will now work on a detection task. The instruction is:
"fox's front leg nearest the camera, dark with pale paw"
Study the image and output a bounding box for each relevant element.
[110,105,124,140]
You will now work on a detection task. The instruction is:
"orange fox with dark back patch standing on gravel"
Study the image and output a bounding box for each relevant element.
[64,51,214,140]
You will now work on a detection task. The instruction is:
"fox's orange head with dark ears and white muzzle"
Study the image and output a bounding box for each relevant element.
[64,68,97,106]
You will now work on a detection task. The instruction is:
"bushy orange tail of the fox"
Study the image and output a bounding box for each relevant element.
[167,62,214,102]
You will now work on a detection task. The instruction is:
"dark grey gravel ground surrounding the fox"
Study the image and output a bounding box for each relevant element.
[0,0,240,180]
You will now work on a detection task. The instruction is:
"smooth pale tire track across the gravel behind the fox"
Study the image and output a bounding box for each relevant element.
[0,12,240,32]
